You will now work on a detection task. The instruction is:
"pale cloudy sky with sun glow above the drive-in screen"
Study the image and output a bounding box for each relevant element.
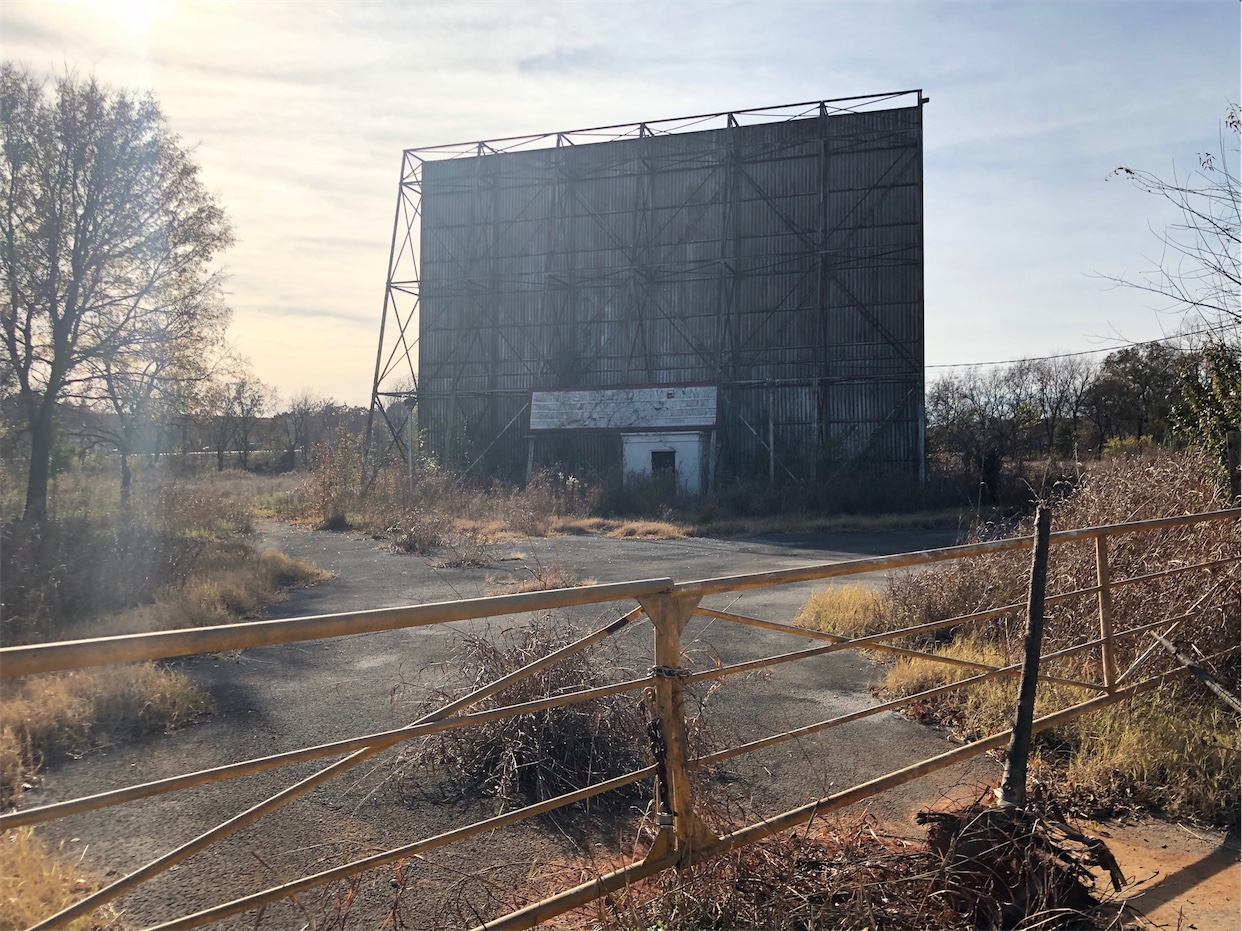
[0,0,1242,405]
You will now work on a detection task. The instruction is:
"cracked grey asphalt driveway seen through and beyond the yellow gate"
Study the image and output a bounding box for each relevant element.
[29,524,987,929]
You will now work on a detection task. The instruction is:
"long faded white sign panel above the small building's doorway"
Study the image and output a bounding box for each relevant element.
[530,385,715,430]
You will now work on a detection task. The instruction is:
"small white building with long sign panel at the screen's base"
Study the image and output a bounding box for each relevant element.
[530,385,718,494]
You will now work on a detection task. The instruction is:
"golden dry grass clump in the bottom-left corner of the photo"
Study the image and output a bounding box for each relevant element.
[0,828,124,931]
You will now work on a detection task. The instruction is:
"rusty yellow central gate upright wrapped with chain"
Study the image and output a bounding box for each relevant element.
[638,595,715,865]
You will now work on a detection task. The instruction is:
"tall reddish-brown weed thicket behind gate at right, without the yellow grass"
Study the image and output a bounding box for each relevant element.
[889,451,1242,683]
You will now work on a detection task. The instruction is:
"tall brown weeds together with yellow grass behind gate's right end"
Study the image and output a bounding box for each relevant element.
[859,451,1242,823]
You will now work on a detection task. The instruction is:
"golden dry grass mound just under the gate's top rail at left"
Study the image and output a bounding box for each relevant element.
[0,663,210,807]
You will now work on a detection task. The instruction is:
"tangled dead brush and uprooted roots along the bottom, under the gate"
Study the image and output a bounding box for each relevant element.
[573,802,1122,931]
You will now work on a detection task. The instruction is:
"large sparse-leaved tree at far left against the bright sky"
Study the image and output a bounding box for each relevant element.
[0,63,231,520]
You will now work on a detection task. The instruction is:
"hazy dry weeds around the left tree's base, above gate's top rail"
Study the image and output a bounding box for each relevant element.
[0,472,320,644]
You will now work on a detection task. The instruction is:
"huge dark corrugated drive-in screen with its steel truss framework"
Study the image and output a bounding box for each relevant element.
[366,91,927,489]
